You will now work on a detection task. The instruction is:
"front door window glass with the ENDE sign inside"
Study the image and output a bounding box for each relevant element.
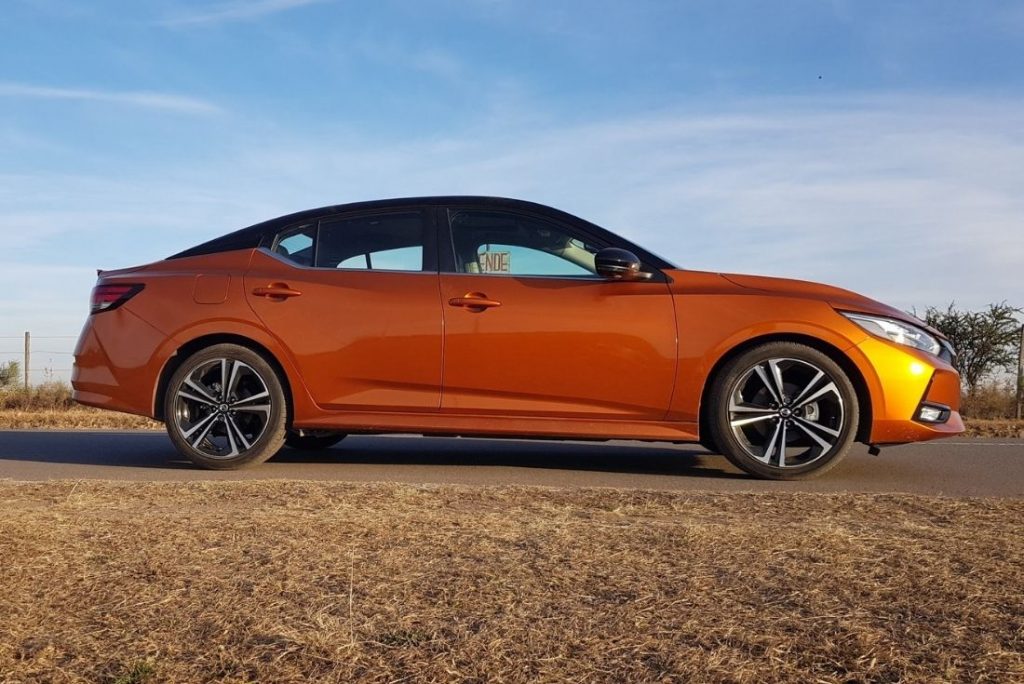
[450,211,600,276]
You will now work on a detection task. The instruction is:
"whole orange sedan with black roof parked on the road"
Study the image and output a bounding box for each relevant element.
[73,197,963,478]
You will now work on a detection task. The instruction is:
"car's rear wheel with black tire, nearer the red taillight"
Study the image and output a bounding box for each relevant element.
[164,344,288,470]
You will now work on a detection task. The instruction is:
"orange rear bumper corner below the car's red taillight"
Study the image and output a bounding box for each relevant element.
[71,306,166,418]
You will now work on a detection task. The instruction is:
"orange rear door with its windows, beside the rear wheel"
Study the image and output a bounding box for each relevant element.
[245,208,442,411]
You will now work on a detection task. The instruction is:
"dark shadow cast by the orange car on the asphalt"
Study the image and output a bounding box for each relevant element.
[0,430,746,479]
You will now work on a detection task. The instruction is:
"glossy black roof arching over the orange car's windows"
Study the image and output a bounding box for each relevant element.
[168,195,675,268]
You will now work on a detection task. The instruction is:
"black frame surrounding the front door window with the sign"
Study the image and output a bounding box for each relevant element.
[434,204,669,283]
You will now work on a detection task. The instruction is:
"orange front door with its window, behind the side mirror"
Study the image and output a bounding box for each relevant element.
[438,206,676,420]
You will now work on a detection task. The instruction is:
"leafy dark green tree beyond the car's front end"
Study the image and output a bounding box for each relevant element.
[925,302,1024,395]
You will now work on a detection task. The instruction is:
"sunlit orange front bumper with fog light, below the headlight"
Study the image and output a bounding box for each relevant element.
[854,337,964,444]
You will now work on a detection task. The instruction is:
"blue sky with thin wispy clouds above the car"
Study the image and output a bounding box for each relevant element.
[0,0,1024,378]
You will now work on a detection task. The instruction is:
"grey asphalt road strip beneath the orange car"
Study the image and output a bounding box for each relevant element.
[0,430,1024,498]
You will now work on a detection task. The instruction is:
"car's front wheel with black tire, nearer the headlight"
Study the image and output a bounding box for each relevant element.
[708,342,860,480]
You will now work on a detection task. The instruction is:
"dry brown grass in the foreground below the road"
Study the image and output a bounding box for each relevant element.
[0,482,1024,682]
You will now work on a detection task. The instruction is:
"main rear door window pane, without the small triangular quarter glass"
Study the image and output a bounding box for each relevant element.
[315,212,424,270]
